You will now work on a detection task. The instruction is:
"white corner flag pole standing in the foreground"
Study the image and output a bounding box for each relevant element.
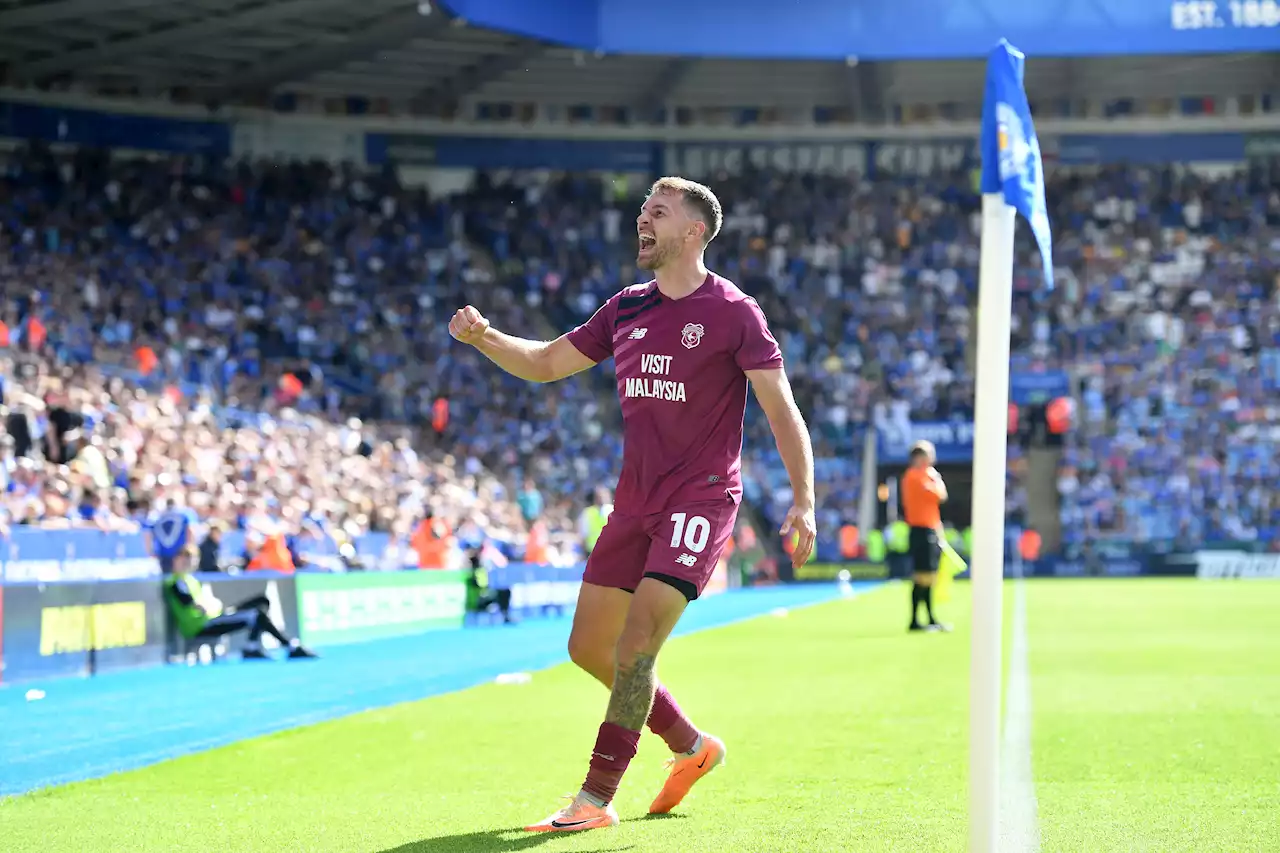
[969,192,1018,853]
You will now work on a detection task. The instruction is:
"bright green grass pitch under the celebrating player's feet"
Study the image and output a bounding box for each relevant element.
[0,579,1280,853]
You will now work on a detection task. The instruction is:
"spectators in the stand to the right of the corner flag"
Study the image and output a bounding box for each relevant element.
[1034,164,1280,549]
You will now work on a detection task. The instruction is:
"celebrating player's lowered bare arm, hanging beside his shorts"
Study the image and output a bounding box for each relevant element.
[745,368,818,567]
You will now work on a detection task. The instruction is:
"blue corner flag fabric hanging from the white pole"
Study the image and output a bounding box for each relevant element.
[980,38,1053,288]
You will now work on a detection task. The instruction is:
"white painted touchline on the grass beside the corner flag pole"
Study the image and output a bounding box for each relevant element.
[1000,578,1041,853]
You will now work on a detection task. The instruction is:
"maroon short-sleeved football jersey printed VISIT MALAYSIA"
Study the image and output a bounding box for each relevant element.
[568,273,782,515]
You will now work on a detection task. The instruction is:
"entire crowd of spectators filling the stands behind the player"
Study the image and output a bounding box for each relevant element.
[0,137,1280,558]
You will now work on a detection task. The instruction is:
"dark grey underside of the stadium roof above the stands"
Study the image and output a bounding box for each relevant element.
[0,0,1280,118]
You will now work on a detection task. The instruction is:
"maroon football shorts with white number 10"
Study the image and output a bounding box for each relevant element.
[582,497,737,601]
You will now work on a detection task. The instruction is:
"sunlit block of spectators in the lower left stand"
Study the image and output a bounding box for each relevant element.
[0,348,588,560]
